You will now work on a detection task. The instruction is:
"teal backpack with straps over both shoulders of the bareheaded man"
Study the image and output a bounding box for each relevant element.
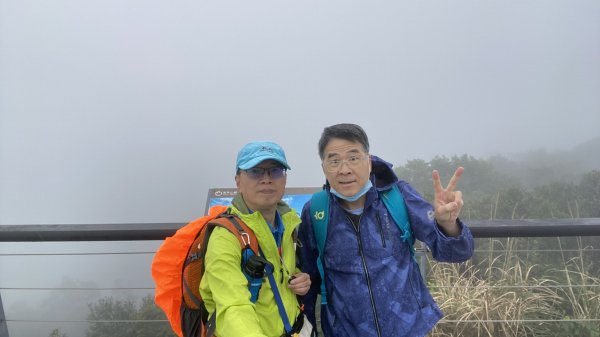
[310,184,415,304]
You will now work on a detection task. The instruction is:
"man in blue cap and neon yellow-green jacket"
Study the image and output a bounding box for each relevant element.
[200,142,310,337]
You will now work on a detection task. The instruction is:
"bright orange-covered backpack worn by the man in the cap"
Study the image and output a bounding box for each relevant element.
[152,206,258,337]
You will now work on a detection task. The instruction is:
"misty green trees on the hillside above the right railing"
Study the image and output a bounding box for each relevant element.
[395,137,600,219]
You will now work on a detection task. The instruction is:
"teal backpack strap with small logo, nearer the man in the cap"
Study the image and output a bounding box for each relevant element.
[310,190,329,304]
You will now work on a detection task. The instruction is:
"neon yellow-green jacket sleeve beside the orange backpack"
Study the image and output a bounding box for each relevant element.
[200,227,266,337]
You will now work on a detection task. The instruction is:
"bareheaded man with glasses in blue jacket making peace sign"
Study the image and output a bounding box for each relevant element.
[300,124,473,337]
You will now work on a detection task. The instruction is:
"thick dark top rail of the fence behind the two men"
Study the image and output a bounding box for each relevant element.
[0,218,600,242]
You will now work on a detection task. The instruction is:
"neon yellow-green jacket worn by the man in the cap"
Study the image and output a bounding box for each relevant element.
[200,194,300,337]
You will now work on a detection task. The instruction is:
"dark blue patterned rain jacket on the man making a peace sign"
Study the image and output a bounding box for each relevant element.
[299,156,473,337]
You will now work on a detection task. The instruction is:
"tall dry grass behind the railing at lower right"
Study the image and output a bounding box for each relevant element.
[427,239,600,337]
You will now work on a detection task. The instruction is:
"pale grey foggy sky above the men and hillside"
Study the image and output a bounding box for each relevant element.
[0,0,600,224]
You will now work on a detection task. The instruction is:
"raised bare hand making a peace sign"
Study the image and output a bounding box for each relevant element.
[431,167,465,236]
